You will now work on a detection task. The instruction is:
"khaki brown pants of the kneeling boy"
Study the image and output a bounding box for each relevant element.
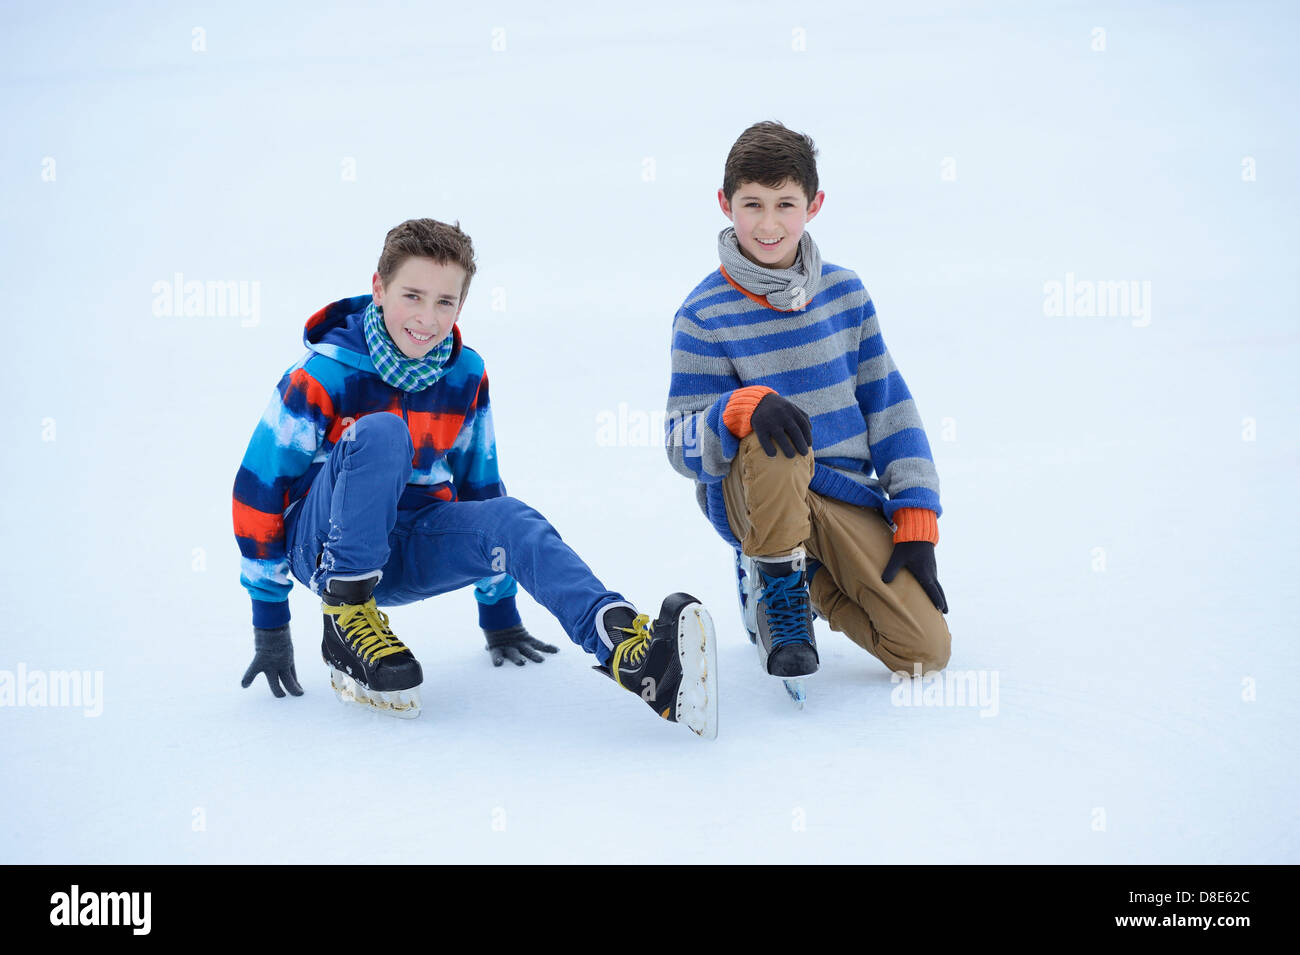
[723,434,953,674]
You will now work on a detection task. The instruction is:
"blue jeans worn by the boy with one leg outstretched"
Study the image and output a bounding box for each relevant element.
[285,413,625,663]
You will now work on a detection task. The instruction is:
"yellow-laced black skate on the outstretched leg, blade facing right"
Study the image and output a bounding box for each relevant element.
[595,594,718,739]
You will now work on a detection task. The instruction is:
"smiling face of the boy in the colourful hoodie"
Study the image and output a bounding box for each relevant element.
[371,256,465,359]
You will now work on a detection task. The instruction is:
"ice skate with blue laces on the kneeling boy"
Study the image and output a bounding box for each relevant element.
[740,548,819,706]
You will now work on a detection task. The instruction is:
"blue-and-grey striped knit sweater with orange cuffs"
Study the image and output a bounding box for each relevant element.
[664,262,941,547]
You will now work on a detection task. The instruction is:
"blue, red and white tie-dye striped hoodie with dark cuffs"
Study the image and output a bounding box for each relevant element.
[234,294,514,628]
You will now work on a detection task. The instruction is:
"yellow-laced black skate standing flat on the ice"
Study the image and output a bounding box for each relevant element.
[321,574,424,720]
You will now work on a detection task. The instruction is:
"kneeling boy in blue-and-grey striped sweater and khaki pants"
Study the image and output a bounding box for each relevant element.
[666,122,952,693]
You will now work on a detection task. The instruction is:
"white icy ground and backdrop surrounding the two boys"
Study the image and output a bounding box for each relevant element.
[0,3,1300,863]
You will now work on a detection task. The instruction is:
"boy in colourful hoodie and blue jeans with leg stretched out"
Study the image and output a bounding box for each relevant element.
[234,218,718,737]
